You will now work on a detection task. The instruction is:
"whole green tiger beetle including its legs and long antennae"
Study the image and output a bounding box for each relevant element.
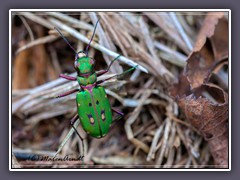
[55,20,137,146]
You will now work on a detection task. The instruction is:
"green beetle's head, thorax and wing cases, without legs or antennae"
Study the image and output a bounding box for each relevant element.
[75,53,112,138]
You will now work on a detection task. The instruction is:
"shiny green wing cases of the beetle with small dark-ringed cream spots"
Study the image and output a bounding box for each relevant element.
[76,81,112,138]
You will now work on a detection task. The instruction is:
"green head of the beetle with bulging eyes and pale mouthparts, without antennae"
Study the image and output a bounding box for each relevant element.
[74,51,95,75]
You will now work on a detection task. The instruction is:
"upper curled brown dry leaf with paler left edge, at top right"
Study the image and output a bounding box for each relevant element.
[186,12,228,88]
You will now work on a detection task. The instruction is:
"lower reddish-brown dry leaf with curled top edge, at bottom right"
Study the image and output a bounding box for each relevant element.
[171,73,228,168]
